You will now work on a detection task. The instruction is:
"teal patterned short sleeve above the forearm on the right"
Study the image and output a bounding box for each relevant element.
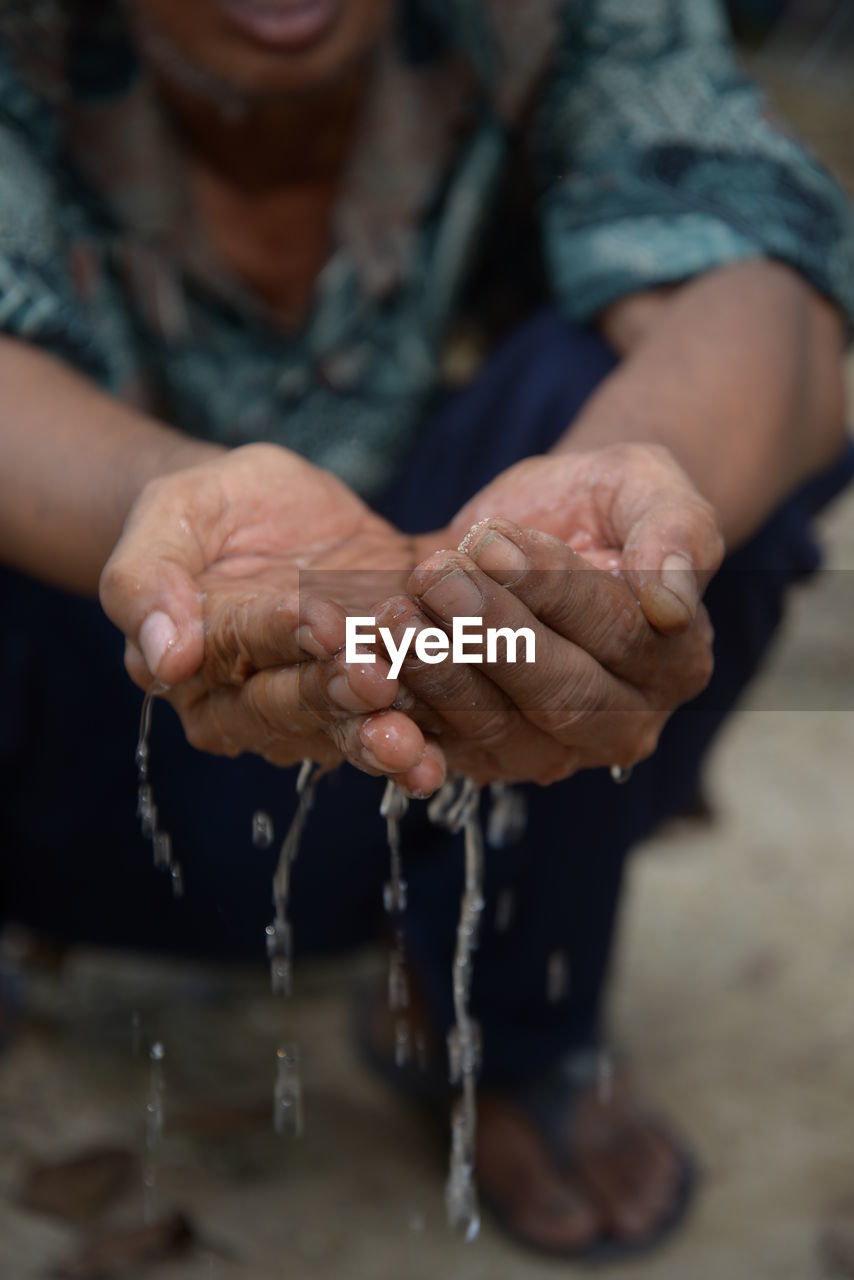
[534,0,854,330]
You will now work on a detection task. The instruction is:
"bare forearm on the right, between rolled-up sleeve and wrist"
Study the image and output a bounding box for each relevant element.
[558,262,845,547]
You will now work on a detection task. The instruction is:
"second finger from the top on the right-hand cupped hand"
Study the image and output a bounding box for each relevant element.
[410,553,657,763]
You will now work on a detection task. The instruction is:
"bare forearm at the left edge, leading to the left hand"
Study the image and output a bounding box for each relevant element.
[0,338,222,595]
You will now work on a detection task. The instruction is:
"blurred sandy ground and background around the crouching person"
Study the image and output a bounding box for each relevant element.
[0,0,854,1280]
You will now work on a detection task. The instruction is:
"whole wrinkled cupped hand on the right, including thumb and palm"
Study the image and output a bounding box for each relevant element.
[332,444,723,783]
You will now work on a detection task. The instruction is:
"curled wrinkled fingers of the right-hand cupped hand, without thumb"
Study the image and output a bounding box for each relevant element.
[368,520,712,783]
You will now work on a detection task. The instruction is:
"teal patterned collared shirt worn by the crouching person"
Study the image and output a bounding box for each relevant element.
[0,0,854,495]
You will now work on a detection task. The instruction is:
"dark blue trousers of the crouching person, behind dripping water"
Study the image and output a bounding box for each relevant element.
[0,311,854,1079]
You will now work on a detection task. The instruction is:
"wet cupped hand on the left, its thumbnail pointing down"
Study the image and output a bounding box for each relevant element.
[101,445,444,794]
